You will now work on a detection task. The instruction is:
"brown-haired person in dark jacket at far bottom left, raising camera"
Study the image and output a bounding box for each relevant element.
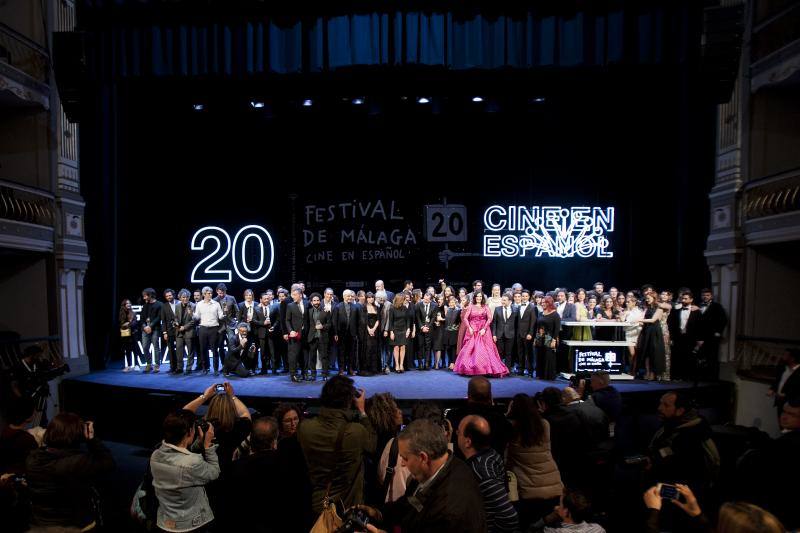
[25,413,115,531]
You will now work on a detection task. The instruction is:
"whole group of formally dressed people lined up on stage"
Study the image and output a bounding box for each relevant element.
[119,280,727,382]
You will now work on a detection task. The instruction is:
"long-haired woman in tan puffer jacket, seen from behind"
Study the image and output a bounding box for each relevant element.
[506,394,564,531]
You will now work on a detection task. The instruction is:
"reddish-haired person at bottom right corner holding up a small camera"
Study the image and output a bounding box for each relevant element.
[644,483,785,533]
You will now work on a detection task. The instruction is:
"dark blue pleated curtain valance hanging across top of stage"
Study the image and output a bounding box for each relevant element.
[78,2,702,79]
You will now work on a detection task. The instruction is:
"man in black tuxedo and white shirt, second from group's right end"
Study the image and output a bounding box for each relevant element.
[667,290,703,380]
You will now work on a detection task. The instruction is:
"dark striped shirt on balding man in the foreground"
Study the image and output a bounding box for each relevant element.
[467,447,519,533]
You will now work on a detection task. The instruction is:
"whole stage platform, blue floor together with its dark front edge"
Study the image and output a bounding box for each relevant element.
[60,365,734,446]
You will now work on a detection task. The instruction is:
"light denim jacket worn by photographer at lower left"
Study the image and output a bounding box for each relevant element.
[150,442,219,533]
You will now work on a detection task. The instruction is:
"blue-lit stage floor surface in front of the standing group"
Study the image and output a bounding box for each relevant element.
[67,366,692,401]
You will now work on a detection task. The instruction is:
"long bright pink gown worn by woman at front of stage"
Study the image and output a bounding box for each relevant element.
[453,305,508,377]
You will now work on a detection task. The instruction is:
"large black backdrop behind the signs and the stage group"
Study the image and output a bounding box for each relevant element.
[83,72,714,366]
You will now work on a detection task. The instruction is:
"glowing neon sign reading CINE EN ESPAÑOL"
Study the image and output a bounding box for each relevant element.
[483,205,614,258]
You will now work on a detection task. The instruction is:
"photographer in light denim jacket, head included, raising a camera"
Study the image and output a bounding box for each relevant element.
[150,409,220,532]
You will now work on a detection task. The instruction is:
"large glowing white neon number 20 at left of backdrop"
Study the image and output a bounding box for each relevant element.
[191,225,275,283]
